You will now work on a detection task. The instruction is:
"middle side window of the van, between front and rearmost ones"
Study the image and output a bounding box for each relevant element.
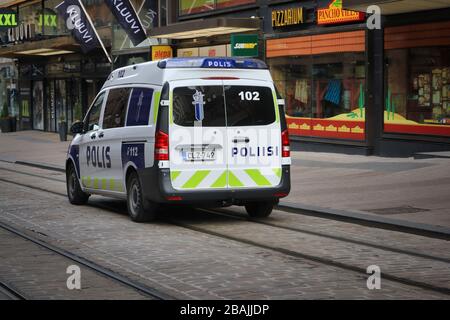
[102,88,131,129]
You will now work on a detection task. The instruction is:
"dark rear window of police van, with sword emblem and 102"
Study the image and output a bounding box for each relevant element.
[173,85,275,127]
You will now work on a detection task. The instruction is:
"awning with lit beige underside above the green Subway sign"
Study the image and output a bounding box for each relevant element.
[148,18,261,39]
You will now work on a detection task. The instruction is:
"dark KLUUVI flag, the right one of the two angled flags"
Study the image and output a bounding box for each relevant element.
[105,0,147,46]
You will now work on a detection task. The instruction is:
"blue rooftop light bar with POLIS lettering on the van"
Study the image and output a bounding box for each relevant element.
[158,57,268,69]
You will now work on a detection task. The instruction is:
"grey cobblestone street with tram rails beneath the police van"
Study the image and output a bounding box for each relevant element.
[0,163,450,299]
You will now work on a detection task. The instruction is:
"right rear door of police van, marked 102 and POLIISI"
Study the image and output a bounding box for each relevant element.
[223,80,282,189]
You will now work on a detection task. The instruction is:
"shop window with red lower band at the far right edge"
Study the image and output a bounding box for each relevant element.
[384,47,450,136]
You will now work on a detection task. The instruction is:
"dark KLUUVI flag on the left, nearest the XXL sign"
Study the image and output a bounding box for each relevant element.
[55,0,101,53]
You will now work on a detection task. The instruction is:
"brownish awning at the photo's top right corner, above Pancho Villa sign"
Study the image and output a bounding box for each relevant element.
[342,0,450,15]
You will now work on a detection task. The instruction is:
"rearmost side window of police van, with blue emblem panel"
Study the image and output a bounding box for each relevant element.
[127,88,154,127]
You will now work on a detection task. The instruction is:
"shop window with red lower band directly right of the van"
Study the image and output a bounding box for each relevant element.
[269,52,365,140]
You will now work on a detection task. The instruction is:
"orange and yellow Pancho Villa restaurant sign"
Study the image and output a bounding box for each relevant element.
[317,0,365,24]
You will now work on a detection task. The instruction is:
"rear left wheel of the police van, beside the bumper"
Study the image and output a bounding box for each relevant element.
[127,172,156,222]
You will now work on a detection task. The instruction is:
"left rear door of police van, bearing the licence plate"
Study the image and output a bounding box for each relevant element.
[169,79,228,190]
